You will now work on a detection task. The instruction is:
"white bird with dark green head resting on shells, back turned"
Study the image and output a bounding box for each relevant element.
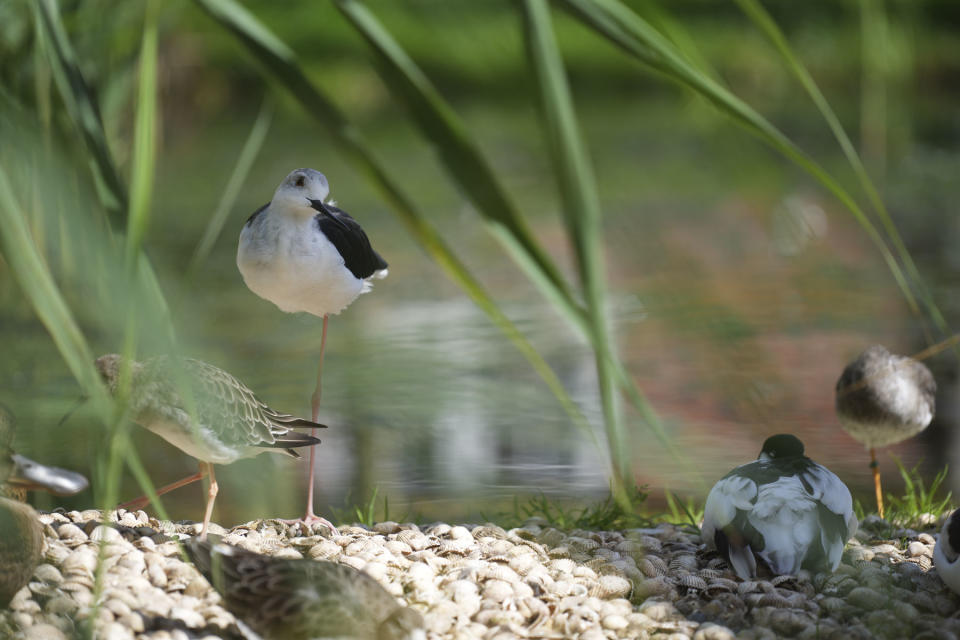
[701,434,858,580]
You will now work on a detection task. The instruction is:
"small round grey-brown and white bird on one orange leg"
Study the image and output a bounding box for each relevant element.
[836,344,937,518]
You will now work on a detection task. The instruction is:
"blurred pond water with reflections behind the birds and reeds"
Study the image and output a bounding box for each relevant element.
[0,95,955,524]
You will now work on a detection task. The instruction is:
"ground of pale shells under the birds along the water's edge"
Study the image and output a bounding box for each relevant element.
[0,510,960,640]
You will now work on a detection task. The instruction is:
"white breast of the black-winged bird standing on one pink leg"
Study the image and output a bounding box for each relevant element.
[237,208,369,316]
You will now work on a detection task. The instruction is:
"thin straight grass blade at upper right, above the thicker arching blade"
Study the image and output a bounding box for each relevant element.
[736,0,950,344]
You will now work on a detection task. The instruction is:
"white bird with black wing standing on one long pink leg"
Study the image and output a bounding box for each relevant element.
[237,169,387,524]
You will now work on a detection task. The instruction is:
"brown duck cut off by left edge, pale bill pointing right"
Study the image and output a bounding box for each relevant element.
[0,406,87,607]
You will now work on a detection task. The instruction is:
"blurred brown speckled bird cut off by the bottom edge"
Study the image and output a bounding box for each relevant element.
[184,538,426,640]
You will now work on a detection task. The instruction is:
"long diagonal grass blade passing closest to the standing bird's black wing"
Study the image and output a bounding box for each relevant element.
[194,0,599,447]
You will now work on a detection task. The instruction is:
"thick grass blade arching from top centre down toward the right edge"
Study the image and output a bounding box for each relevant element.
[562,0,920,330]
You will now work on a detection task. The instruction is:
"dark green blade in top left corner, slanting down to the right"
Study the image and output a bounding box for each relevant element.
[29,0,127,226]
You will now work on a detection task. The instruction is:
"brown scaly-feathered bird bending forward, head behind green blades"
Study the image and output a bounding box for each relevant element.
[96,354,325,537]
